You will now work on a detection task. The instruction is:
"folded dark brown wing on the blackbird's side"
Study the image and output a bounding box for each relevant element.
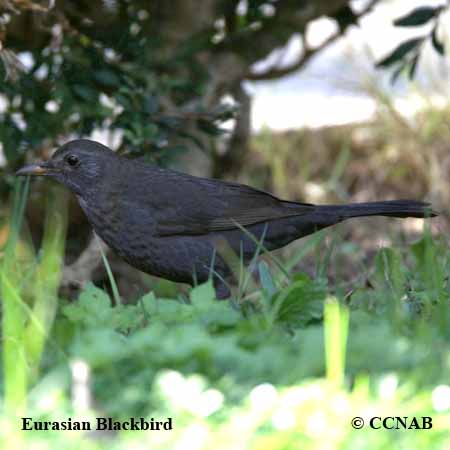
[146,172,315,236]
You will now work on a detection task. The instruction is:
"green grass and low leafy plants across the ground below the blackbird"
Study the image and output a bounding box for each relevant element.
[0,184,450,450]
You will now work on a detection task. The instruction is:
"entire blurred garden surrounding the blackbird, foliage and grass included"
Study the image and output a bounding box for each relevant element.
[0,0,450,449]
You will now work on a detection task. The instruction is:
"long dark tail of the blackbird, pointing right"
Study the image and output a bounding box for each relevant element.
[319,200,438,220]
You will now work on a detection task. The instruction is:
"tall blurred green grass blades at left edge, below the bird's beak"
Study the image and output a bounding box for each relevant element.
[0,180,66,426]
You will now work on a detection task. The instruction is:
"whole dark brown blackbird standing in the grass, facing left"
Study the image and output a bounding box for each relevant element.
[17,139,436,298]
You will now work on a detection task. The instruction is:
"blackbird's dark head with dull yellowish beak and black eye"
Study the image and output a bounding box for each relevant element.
[16,139,118,197]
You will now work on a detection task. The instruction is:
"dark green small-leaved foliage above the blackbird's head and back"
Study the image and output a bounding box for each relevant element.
[0,3,234,174]
